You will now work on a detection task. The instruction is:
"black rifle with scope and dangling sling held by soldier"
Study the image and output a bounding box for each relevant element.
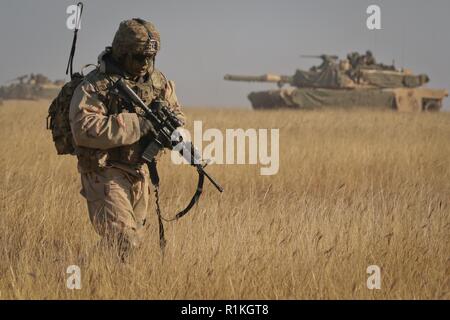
[112,78,223,251]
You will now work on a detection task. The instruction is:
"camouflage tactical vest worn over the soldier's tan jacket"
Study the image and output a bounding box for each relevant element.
[75,69,167,172]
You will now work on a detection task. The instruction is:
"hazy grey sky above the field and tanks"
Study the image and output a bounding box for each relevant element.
[0,0,450,107]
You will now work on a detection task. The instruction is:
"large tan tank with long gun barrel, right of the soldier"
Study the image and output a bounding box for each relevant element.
[224,51,448,111]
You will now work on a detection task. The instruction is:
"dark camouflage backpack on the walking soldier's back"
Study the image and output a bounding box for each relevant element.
[47,73,84,155]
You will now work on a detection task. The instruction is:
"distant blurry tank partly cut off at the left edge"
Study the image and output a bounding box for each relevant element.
[0,73,64,100]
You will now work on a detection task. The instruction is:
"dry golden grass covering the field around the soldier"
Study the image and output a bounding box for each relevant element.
[0,101,450,299]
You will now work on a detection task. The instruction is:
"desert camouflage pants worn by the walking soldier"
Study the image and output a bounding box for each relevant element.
[81,168,149,251]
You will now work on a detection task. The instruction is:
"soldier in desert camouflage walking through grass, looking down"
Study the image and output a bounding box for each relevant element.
[69,19,183,258]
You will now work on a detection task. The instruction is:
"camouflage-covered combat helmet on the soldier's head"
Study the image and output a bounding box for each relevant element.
[111,18,161,61]
